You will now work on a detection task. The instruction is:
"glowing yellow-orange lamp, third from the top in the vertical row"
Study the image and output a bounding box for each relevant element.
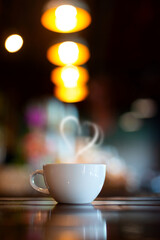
[51,65,89,88]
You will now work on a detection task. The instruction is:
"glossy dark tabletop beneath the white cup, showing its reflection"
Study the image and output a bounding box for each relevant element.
[0,197,160,240]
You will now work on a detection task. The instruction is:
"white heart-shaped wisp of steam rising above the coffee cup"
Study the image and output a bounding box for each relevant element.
[60,116,99,158]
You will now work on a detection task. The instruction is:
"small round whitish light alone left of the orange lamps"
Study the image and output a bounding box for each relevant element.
[5,34,23,53]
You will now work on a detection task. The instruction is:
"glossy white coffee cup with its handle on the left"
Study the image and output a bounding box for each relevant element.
[30,163,106,204]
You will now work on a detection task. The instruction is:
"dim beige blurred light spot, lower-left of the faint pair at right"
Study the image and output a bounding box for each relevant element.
[119,112,142,132]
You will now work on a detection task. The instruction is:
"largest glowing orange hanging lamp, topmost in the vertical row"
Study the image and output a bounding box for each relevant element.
[41,2,91,33]
